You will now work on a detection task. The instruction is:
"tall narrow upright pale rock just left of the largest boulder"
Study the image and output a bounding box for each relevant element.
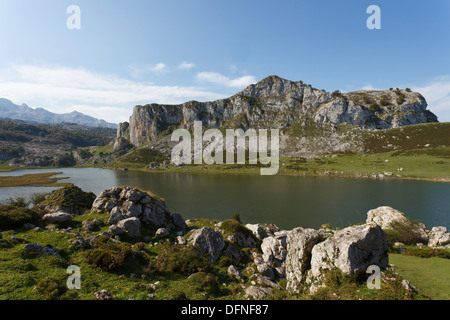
[286,228,321,292]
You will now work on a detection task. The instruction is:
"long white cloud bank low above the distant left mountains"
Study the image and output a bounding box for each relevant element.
[0,65,225,123]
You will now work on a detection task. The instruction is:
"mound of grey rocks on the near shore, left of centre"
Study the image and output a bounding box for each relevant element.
[92,187,186,237]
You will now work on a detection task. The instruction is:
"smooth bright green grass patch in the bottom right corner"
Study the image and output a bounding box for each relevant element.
[389,254,450,300]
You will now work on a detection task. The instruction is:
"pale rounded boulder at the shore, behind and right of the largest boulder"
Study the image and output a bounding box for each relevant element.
[366,206,428,244]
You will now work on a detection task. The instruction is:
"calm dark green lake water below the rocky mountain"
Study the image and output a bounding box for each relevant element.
[0,168,450,229]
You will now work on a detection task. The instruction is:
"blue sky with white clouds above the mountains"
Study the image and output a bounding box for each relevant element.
[0,0,450,122]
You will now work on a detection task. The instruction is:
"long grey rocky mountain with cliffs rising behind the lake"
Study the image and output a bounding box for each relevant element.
[118,76,438,146]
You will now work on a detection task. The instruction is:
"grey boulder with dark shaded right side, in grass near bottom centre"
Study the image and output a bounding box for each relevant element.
[188,227,225,263]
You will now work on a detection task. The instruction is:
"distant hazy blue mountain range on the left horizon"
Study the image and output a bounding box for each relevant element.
[0,98,117,128]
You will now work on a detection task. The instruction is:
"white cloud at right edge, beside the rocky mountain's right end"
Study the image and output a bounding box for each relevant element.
[411,77,450,122]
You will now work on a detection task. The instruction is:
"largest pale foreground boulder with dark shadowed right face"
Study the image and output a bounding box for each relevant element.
[311,223,389,279]
